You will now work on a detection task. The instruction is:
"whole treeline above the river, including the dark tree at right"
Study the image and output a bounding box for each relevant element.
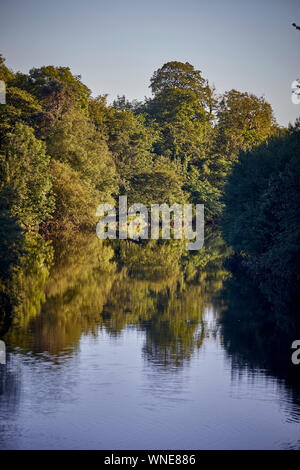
[0,57,300,310]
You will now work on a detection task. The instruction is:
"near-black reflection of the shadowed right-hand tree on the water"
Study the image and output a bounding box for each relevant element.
[220,260,300,421]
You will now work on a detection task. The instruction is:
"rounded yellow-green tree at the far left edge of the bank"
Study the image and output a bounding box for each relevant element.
[0,123,54,227]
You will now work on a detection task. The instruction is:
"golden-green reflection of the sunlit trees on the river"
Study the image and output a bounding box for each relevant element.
[1,234,226,366]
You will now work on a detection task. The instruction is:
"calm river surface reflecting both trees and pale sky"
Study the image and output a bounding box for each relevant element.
[0,227,300,448]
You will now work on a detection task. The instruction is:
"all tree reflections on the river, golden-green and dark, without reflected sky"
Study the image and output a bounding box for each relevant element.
[0,230,300,419]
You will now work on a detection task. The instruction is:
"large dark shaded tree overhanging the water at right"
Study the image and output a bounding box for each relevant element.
[223,128,300,305]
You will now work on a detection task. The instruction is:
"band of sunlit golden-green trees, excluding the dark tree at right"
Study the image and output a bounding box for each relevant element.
[0,53,287,280]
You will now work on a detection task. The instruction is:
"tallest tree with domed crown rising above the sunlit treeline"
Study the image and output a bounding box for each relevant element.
[146,62,214,164]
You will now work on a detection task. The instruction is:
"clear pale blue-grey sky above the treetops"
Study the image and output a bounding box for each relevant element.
[0,0,300,125]
